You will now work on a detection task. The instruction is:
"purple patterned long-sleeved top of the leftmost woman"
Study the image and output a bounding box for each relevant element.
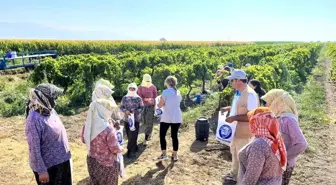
[26,110,71,174]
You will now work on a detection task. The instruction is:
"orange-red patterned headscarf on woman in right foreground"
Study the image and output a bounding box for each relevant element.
[247,107,287,170]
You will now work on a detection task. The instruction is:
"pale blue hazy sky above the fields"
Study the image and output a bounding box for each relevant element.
[0,0,336,41]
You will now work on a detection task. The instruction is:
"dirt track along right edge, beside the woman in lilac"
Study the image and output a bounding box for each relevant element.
[291,57,336,185]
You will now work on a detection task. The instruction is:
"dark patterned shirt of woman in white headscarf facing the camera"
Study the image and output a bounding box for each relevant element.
[120,96,144,122]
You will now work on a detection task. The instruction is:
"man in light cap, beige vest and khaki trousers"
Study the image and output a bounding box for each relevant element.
[221,69,259,183]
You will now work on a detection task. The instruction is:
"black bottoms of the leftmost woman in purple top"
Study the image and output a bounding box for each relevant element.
[34,161,72,185]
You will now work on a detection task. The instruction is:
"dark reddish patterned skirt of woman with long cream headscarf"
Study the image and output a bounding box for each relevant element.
[87,156,119,185]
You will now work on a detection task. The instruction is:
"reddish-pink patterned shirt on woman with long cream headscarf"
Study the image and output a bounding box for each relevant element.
[82,125,122,166]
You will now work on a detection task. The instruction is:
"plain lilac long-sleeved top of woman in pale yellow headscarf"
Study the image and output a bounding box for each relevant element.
[278,116,308,167]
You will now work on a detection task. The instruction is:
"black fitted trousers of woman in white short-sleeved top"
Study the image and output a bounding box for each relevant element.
[160,122,181,151]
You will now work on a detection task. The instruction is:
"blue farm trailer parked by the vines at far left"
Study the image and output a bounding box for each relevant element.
[0,50,58,70]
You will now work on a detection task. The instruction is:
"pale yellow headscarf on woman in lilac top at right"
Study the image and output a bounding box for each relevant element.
[261,89,298,120]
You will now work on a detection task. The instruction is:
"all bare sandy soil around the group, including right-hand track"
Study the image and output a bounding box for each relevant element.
[0,58,336,185]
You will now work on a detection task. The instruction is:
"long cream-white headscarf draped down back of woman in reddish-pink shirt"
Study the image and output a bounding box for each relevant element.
[84,79,118,152]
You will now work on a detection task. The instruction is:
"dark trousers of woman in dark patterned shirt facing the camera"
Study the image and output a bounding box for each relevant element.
[124,121,140,153]
